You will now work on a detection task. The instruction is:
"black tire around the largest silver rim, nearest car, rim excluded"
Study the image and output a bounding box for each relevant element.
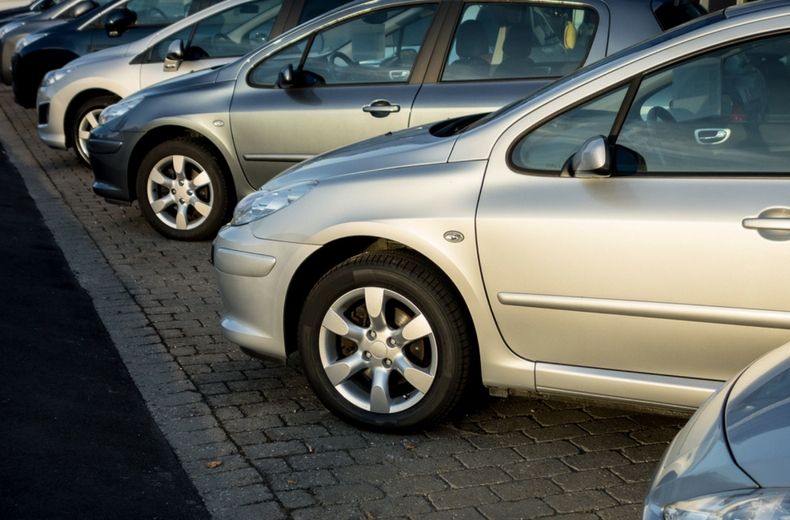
[299,256,463,430]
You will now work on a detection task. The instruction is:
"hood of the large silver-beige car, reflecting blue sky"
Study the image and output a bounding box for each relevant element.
[261,126,455,189]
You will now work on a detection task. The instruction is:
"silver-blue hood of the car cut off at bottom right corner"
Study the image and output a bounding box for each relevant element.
[725,343,790,487]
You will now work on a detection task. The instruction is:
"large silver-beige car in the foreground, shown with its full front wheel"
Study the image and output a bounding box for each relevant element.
[212,2,790,429]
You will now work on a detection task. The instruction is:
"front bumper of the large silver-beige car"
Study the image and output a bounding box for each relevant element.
[213,225,319,360]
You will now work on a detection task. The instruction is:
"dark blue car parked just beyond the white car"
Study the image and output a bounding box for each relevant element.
[11,0,219,108]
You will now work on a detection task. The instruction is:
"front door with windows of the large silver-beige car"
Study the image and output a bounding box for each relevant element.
[477,31,790,386]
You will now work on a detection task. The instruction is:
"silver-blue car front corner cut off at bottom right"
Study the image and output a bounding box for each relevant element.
[643,345,790,520]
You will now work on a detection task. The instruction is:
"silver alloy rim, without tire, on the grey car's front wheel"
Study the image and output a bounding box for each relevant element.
[146,155,214,231]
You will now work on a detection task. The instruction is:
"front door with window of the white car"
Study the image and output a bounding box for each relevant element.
[140,0,287,88]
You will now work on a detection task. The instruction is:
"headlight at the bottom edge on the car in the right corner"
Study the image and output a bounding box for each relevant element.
[664,489,790,520]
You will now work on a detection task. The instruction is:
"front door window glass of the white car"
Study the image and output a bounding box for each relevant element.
[185,0,283,60]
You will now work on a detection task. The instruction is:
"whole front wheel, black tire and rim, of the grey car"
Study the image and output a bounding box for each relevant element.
[136,137,230,241]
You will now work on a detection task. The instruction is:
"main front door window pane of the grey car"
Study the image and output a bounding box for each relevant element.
[304,4,436,85]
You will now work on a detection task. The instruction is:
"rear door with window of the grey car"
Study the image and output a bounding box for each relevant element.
[410,0,609,126]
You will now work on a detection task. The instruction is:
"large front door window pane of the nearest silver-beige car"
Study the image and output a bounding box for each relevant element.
[615,35,790,173]
